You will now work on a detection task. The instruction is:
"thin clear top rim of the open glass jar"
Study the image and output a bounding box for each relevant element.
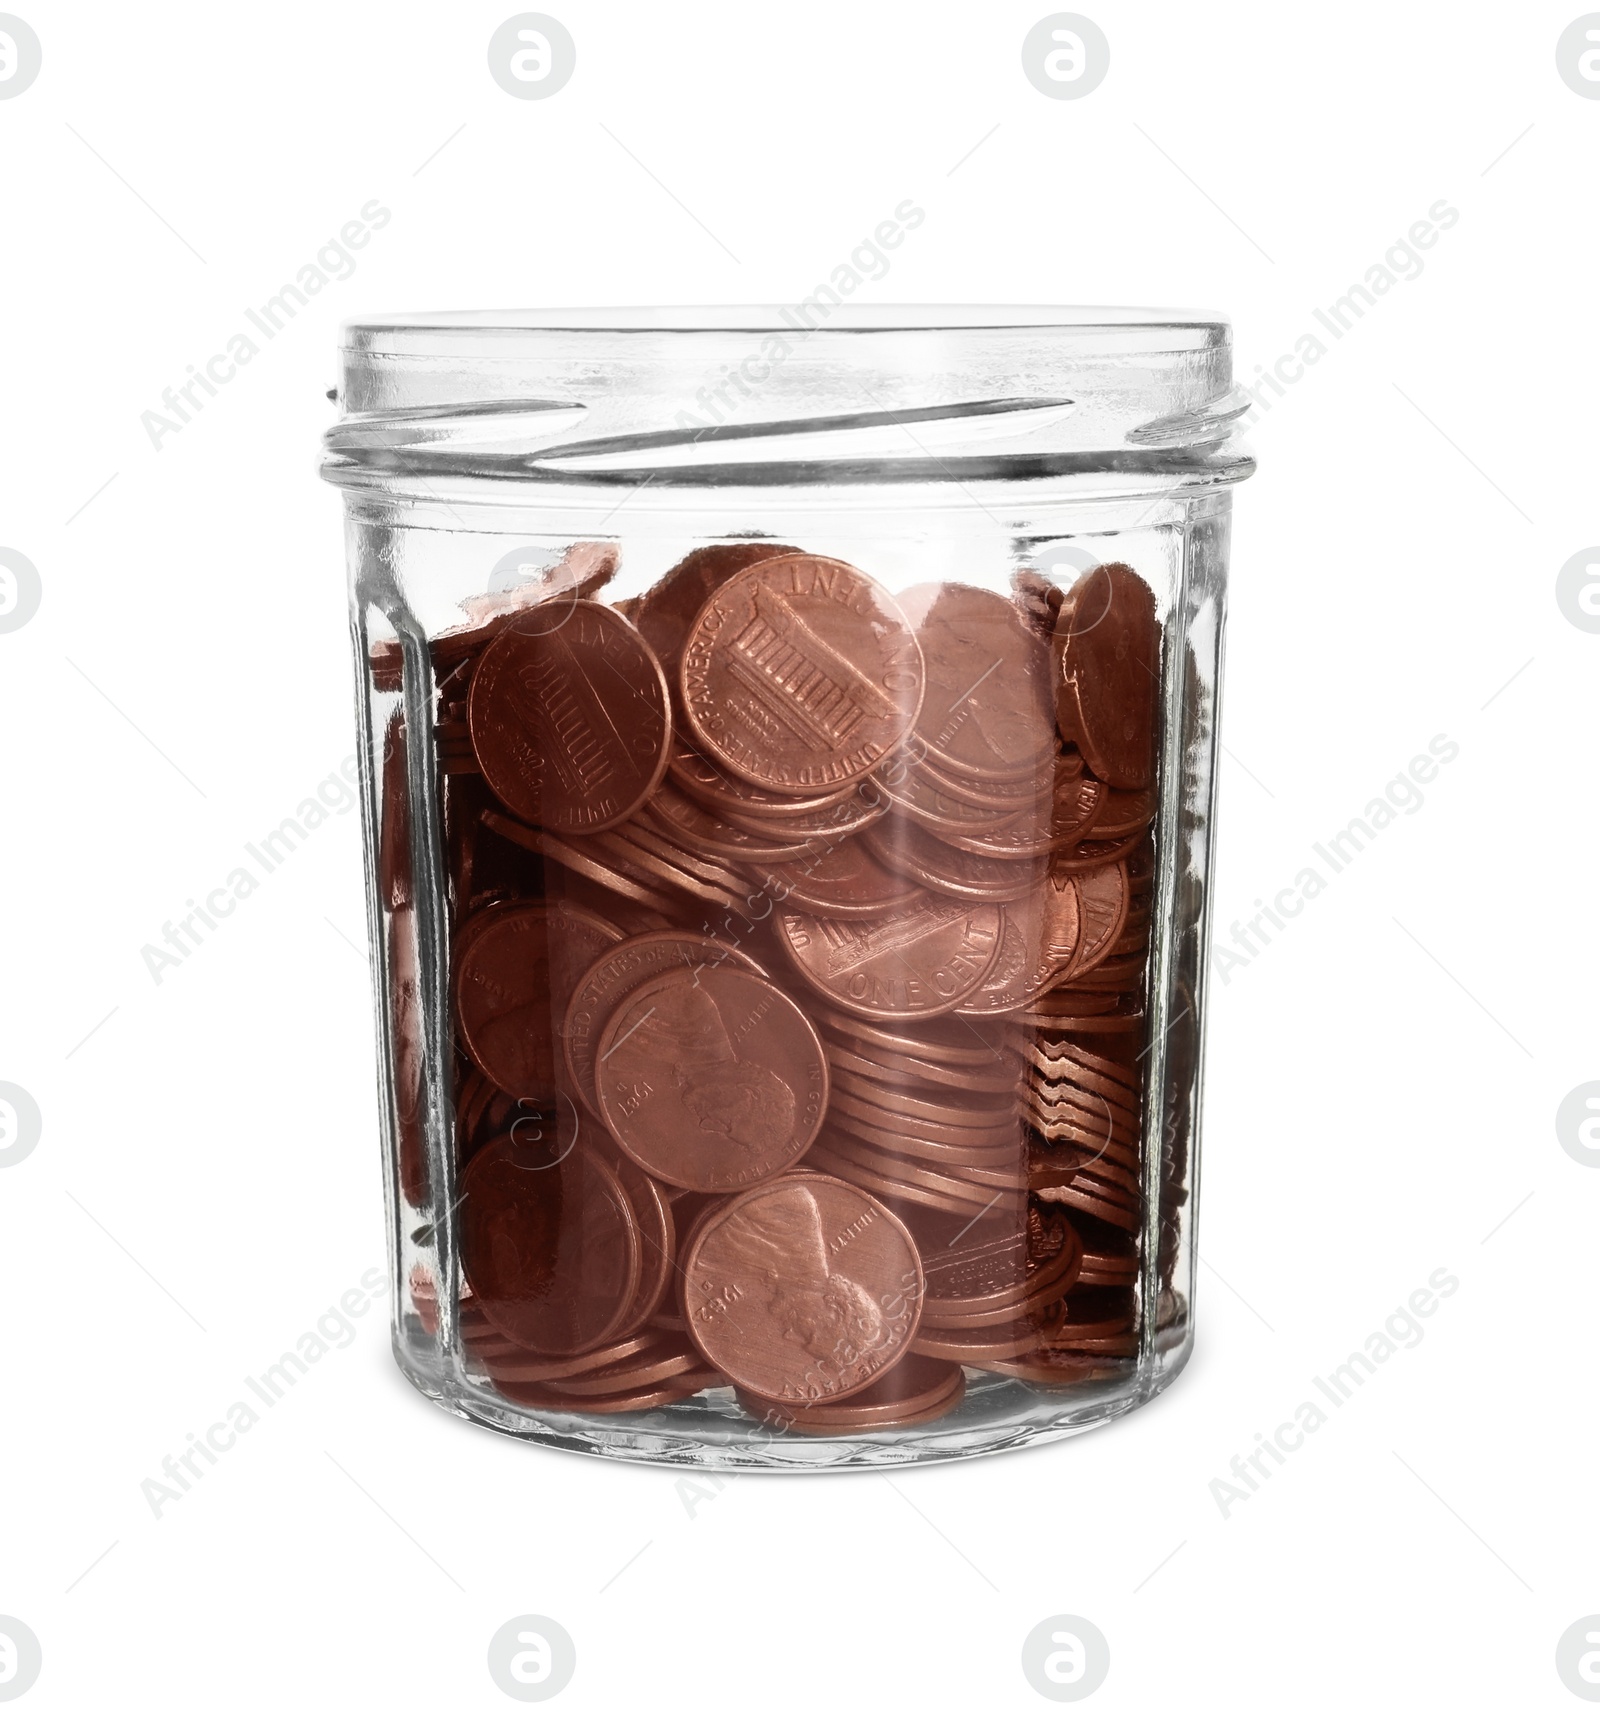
[342,305,1229,350]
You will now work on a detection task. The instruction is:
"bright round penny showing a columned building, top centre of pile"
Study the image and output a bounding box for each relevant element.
[680,553,922,793]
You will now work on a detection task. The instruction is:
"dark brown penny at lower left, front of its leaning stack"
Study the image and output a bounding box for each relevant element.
[460,1138,640,1355]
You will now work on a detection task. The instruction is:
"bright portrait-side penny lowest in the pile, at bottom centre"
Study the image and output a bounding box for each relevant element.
[683,1173,924,1403]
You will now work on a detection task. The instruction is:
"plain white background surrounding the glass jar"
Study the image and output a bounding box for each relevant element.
[0,0,1600,1712]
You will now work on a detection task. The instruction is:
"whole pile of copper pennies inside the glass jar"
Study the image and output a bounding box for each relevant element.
[381,543,1161,1435]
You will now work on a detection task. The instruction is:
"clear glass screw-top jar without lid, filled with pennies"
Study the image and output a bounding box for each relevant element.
[323,304,1253,1468]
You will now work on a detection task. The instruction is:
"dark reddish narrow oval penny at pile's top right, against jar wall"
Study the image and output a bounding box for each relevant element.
[1054,561,1161,788]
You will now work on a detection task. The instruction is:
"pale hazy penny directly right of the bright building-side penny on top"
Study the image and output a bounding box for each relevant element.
[898,584,1056,778]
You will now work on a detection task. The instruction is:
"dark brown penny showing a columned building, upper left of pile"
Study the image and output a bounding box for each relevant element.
[467,601,671,834]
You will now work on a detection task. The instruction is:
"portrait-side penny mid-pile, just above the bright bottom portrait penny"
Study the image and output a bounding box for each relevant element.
[594,965,827,1192]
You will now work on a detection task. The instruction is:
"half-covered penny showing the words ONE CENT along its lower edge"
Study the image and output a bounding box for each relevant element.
[778,896,1001,1020]
